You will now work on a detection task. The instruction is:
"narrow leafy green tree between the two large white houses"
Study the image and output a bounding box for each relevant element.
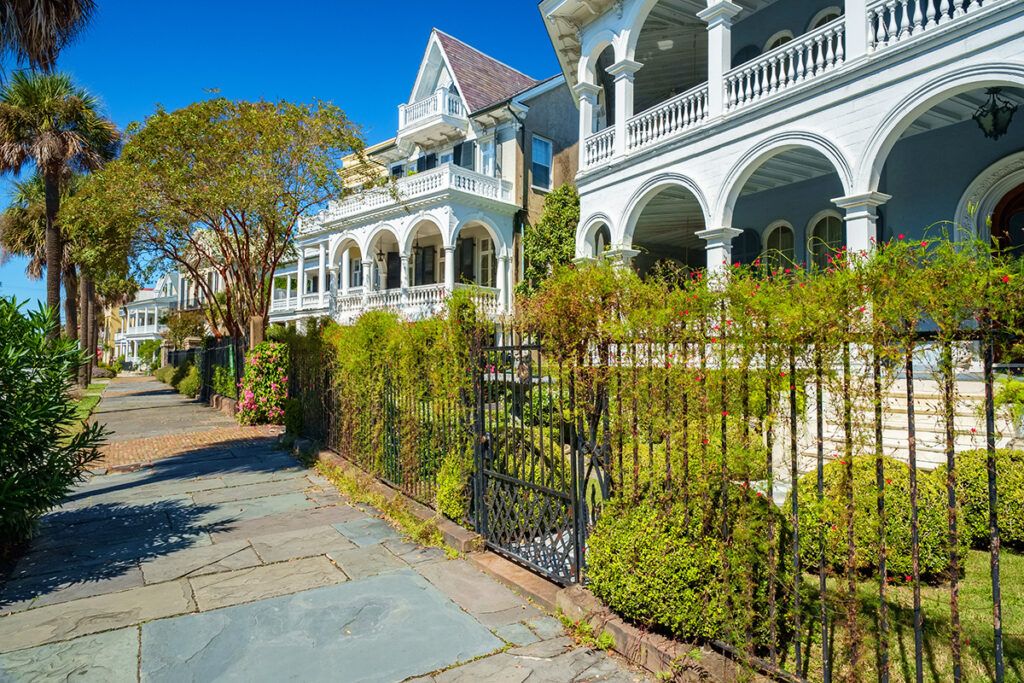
[519,184,580,293]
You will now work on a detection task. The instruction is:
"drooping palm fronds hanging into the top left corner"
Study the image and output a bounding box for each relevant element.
[0,0,96,72]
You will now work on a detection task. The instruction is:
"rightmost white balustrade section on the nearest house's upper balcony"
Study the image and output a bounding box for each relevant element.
[867,0,997,52]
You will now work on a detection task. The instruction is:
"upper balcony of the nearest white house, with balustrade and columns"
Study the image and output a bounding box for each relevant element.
[573,0,1015,174]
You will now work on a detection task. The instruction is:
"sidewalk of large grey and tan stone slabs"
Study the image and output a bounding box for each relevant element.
[0,379,644,683]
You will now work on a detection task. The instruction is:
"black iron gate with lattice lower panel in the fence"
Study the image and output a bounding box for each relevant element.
[474,336,608,584]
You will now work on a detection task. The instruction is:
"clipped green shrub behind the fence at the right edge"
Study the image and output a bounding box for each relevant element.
[932,450,1024,550]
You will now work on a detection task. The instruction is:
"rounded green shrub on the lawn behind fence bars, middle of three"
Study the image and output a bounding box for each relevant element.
[783,456,949,579]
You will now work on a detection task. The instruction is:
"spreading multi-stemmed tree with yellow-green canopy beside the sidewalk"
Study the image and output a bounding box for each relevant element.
[100,98,372,344]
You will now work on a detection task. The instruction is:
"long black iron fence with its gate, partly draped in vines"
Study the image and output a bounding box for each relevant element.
[291,330,1006,683]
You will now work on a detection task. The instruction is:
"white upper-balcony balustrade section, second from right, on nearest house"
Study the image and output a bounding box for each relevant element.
[725,16,846,112]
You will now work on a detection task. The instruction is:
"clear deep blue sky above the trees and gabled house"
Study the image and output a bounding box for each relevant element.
[0,0,559,300]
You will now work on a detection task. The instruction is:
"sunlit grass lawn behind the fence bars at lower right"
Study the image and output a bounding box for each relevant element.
[786,550,1024,683]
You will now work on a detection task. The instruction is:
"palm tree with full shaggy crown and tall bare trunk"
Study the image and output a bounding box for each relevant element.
[0,72,120,331]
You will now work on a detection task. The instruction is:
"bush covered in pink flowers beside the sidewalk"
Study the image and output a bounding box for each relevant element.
[239,342,288,425]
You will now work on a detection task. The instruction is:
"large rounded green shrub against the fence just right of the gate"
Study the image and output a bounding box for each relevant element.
[587,487,792,648]
